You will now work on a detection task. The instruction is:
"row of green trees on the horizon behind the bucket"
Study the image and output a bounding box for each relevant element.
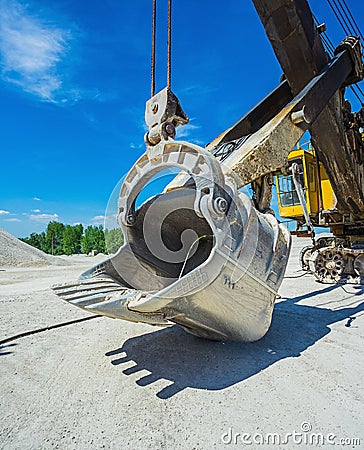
[20,221,124,255]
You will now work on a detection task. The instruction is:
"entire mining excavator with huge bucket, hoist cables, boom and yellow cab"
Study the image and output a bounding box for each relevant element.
[53,0,364,342]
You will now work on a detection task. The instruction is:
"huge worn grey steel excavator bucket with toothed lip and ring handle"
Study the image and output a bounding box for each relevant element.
[53,138,290,342]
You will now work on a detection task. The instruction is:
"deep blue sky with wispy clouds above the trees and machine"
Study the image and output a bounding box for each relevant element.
[0,0,363,236]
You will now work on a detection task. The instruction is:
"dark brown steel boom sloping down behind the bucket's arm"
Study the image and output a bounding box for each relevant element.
[253,0,364,219]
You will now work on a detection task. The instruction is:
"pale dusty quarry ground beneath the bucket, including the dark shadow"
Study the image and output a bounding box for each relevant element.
[0,239,364,450]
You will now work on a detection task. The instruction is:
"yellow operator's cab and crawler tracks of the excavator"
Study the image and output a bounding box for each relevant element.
[275,132,364,283]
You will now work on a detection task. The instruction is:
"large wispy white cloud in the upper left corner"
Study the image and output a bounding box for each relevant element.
[0,0,79,103]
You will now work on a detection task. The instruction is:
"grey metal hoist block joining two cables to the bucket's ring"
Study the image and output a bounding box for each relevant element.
[145,87,188,145]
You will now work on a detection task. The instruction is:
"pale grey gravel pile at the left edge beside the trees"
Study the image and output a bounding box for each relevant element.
[0,229,69,267]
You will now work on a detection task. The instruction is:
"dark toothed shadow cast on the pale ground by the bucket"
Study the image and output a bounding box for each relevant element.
[106,285,364,399]
